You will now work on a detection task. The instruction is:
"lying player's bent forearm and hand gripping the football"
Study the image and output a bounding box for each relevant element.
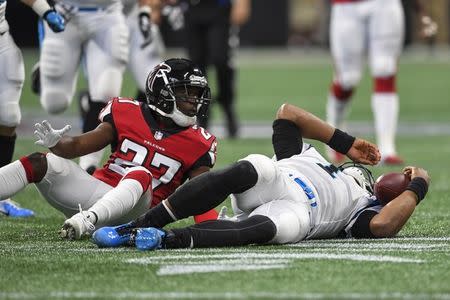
[369,167,430,238]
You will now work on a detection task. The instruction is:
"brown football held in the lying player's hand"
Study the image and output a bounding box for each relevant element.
[374,172,410,205]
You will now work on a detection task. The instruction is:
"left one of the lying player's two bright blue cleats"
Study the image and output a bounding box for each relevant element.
[91,223,135,248]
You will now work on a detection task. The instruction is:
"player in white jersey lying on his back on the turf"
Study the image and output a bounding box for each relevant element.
[93,105,429,250]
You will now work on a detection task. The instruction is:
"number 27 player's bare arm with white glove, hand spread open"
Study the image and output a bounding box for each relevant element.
[34,120,114,159]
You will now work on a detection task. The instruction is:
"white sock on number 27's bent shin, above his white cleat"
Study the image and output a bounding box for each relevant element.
[88,178,144,224]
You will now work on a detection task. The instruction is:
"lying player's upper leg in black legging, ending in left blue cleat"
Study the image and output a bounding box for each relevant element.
[93,161,258,247]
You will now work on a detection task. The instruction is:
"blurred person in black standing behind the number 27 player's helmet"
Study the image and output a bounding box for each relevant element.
[153,0,251,138]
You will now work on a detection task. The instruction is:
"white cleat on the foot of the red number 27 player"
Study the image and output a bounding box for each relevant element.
[59,206,95,240]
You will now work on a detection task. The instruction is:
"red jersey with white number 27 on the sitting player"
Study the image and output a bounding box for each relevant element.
[94,98,217,206]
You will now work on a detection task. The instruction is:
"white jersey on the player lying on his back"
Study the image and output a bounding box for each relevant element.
[277,144,374,239]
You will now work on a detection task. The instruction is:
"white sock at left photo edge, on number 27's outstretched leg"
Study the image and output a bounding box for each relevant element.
[0,160,29,199]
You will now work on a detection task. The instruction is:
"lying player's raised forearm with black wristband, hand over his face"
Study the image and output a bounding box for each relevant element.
[276,104,381,165]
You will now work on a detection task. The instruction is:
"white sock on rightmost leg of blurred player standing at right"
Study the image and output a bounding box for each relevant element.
[372,93,399,157]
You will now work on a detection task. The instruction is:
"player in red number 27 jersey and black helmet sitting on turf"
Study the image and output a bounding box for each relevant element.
[0,59,217,239]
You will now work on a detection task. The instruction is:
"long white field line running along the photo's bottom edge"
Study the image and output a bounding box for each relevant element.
[0,291,450,300]
